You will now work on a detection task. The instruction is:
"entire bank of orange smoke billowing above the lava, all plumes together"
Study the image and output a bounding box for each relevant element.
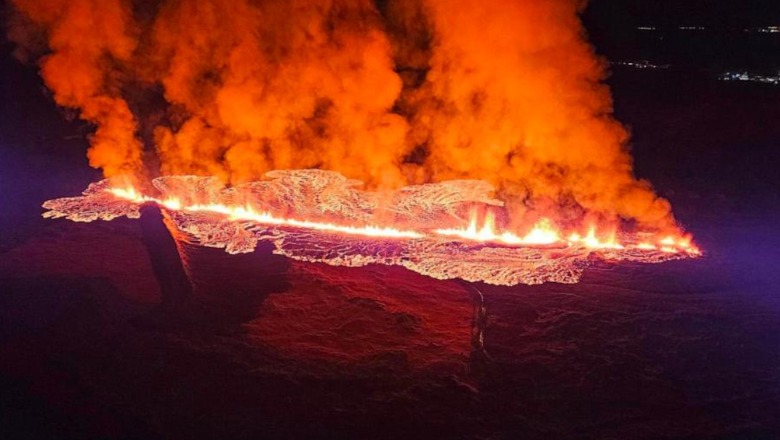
[4,0,674,232]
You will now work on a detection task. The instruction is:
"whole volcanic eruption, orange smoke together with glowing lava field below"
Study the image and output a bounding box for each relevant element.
[9,0,700,285]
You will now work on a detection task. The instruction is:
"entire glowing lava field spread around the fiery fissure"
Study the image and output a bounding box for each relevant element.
[44,170,700,285]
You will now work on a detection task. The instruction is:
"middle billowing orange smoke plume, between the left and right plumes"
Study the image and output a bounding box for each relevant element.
[152,0,407,186]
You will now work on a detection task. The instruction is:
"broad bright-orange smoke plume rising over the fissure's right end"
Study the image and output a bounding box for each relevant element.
[402,0,673,227]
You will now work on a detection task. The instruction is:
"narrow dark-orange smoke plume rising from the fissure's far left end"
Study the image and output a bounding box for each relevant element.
[9,0,142,176]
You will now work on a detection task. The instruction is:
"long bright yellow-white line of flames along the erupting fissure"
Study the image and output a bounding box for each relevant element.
[107,187,701,256]
